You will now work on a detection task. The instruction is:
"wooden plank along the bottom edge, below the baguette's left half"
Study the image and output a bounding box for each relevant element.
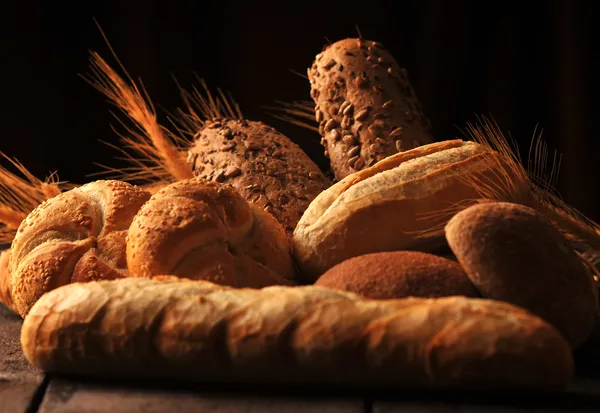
[39,378,365,413]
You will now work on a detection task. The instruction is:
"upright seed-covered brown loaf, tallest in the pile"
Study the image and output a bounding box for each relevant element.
[308,39,433,180]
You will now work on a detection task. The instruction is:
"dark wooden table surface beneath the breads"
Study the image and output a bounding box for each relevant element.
[0,305,600,413]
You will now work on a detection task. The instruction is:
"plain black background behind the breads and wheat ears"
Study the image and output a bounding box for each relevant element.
[0,0,600,220]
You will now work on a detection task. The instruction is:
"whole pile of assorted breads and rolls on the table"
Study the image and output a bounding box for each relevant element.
[0,39,598,389]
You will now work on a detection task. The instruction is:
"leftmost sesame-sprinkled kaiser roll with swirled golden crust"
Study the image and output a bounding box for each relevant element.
[10,180,150,316]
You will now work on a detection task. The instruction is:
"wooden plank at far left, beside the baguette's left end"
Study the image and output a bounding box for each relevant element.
[0,305,43,413]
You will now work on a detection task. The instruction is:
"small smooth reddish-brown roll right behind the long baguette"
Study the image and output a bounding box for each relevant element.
[315,251,479,299]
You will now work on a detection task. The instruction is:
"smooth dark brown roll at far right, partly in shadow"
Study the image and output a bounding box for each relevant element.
[445,202,598,347]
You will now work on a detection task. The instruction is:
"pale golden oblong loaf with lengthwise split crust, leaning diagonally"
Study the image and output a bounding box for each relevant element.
[293,140,508,281]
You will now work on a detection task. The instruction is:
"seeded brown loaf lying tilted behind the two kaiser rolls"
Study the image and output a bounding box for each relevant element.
[188,119,331,236]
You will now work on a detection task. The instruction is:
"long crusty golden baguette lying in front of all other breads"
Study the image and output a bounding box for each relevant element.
[21,277,573,388]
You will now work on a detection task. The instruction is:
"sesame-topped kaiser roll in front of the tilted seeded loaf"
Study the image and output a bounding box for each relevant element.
[127,178,294,288]
